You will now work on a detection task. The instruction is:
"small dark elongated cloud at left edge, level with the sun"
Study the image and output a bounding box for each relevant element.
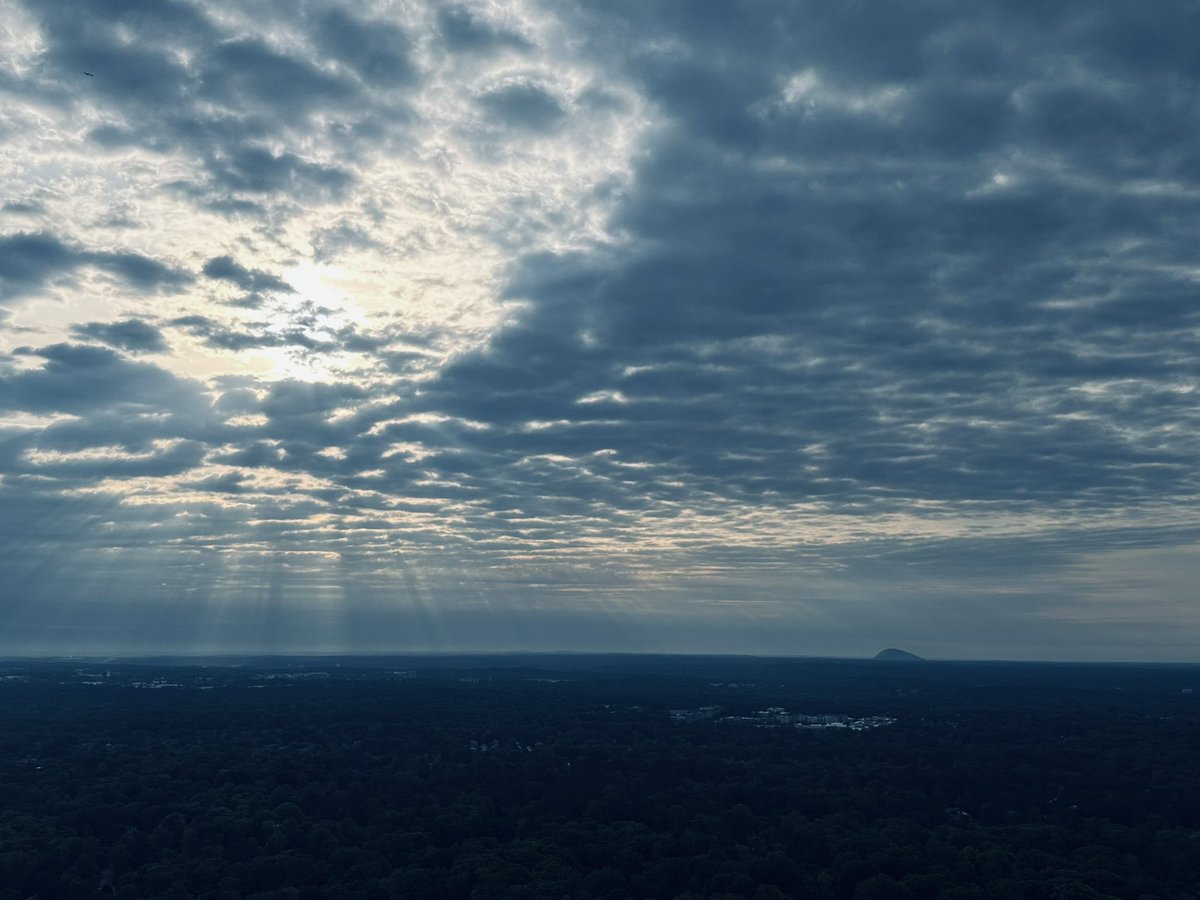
[0,233,192,299]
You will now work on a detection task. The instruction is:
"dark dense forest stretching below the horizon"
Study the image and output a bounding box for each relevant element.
[0,659,1200,900]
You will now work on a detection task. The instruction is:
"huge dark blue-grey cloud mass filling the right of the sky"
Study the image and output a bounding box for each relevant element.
[410,5,1200,528]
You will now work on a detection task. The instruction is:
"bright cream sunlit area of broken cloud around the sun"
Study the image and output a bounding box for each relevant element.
[0,4,657,657]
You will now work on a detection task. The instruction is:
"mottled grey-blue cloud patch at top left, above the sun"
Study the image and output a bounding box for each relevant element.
[14,0,419,215]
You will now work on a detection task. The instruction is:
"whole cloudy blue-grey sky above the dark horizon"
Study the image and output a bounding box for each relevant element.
[0,0,1200,661]
